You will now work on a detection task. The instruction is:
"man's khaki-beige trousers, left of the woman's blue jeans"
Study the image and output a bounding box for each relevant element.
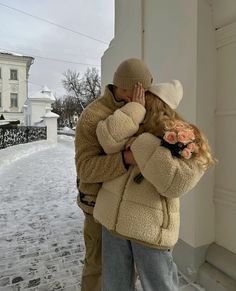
[81,214,102,291]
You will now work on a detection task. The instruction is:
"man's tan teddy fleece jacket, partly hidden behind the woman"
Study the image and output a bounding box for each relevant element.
[75,85,127,214]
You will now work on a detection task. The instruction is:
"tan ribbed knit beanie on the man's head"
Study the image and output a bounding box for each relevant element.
[113,58,153,89]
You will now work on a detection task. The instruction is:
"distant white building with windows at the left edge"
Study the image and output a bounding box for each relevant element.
[0,51,34,124]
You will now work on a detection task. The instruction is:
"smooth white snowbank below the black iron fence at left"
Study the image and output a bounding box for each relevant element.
[0,140,55,170]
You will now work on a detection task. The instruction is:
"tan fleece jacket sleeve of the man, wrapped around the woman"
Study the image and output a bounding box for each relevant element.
[75,110,127,183]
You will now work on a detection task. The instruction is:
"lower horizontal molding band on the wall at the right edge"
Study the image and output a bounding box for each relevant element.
[213,187,236,208]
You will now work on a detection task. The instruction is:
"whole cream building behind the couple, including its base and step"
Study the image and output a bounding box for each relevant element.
[101,0,236,291]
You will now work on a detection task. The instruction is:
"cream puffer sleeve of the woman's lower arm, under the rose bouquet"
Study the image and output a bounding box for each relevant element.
[131,133,204,198]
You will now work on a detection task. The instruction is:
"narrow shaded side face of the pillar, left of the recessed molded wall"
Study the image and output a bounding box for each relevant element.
[195,0,217,246]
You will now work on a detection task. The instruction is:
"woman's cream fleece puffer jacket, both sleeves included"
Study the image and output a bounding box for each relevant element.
[93,102,203,249]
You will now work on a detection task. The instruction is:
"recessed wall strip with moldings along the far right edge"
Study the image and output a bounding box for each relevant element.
[213,0,236,253]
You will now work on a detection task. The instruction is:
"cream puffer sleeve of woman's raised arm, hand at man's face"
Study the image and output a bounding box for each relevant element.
[96,102,146,154]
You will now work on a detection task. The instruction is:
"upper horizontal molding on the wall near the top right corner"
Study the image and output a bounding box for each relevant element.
[215,22,236,48]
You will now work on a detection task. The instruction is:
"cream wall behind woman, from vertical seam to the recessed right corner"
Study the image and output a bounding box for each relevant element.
[144,0,216,247]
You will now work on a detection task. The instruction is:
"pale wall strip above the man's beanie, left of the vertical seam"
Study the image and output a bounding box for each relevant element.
[101,0,142,91]
